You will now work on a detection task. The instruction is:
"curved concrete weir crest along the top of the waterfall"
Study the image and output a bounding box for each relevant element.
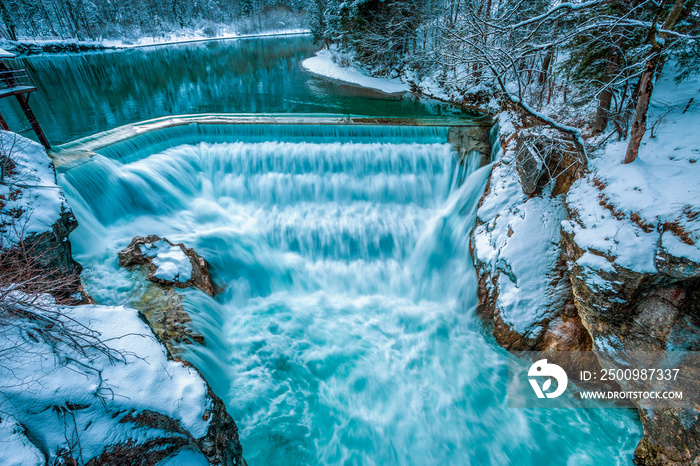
[50,114,493,171]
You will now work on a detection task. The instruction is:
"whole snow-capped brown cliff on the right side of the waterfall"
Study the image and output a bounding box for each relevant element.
[472,106,700,465]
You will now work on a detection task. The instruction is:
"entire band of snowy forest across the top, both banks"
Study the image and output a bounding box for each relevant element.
[0,0,700,161]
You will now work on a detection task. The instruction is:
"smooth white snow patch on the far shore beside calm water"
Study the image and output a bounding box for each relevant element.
[302,49,409,94]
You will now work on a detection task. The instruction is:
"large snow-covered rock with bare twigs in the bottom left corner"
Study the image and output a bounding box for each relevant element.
[0,292,243,464]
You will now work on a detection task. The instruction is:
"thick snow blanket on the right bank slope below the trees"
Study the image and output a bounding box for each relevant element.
[564,69,700,273]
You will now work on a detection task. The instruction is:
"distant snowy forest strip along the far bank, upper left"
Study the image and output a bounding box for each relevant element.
[0,0,305,40]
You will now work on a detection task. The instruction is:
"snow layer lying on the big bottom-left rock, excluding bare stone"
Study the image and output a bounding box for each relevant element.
[0,292,211,464]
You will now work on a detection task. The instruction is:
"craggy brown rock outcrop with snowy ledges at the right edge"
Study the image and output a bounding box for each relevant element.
[562,177,700,466]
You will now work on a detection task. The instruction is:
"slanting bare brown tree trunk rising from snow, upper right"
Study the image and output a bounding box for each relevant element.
[625,0,687,163]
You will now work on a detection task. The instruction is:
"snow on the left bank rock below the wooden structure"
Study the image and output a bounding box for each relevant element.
[0,131,69,247]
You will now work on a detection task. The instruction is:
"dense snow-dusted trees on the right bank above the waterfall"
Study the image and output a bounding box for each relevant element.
[310,0,700,162]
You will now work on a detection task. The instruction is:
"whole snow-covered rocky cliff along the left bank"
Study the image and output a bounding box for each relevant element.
[0,132,245,465]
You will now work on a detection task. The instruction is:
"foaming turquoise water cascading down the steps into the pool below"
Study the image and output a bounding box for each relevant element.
[59,126,641,466]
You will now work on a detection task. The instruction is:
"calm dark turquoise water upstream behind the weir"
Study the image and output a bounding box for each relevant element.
[0,35,473,146]
